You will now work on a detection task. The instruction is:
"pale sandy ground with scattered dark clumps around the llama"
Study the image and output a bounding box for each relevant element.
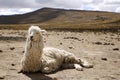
[0,30,120,80]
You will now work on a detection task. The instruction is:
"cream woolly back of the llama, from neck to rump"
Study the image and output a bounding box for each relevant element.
[43,47,75,64]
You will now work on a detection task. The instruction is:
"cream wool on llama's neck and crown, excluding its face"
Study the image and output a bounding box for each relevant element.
[22,26,44,72]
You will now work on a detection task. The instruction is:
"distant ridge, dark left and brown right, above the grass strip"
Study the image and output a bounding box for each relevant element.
[0,7,120,24]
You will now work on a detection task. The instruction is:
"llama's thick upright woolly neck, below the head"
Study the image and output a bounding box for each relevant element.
[23,40,44,71]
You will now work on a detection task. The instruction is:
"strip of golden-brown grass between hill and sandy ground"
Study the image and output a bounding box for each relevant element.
[0,23,120,30]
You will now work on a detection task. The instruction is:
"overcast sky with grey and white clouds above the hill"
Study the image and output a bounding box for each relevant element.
[0,0,120,15]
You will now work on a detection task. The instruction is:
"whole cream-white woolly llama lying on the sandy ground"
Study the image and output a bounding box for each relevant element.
[21,26,93,73]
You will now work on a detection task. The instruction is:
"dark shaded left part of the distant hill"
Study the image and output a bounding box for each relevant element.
[0,8,64,24]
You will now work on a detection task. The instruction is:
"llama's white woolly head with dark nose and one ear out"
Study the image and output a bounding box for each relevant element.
[28,26,45,41]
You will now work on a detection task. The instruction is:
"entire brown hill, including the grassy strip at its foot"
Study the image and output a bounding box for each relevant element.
[0,8,120,29]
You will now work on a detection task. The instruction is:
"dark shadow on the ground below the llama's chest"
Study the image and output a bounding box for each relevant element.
[24,73,54,80]
